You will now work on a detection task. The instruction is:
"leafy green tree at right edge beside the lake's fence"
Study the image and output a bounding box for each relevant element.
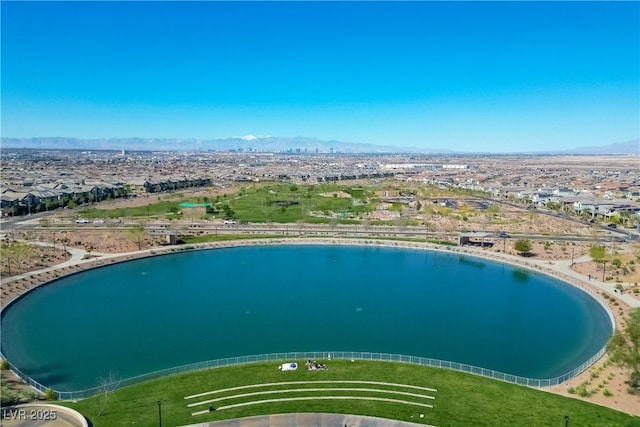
[607,308,640,394]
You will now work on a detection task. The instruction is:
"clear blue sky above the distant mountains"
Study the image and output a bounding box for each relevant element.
[0,1,640,152]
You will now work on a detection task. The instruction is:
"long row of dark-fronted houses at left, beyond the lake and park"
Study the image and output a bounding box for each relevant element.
[0,176,211,217]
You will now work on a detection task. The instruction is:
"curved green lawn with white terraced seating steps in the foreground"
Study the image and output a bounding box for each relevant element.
[57,360,640,427]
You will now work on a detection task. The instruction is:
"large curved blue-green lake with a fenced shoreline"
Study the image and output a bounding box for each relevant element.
[2,245,611,391]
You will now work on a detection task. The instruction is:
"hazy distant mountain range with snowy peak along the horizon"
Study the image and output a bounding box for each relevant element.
[1,135,640,155]
